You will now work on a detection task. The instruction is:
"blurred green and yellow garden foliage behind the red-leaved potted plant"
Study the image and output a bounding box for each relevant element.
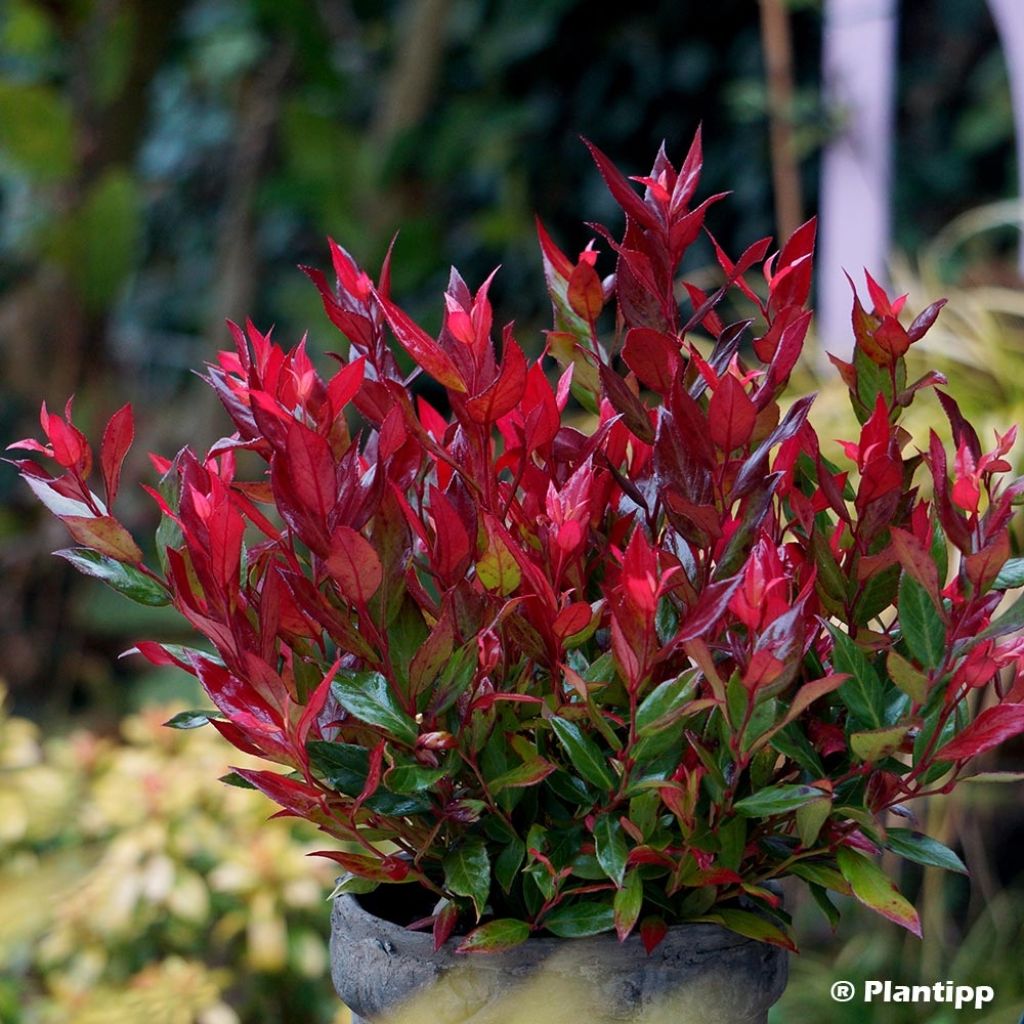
[0,0,1024,1024]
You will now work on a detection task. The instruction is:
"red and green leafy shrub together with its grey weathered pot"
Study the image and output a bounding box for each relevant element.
[12,135,1024,1022]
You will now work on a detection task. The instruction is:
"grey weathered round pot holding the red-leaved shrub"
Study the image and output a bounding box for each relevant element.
[331,896,787,1024]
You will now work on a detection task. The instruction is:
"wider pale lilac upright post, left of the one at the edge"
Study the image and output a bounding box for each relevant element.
[817,0,897,356]
